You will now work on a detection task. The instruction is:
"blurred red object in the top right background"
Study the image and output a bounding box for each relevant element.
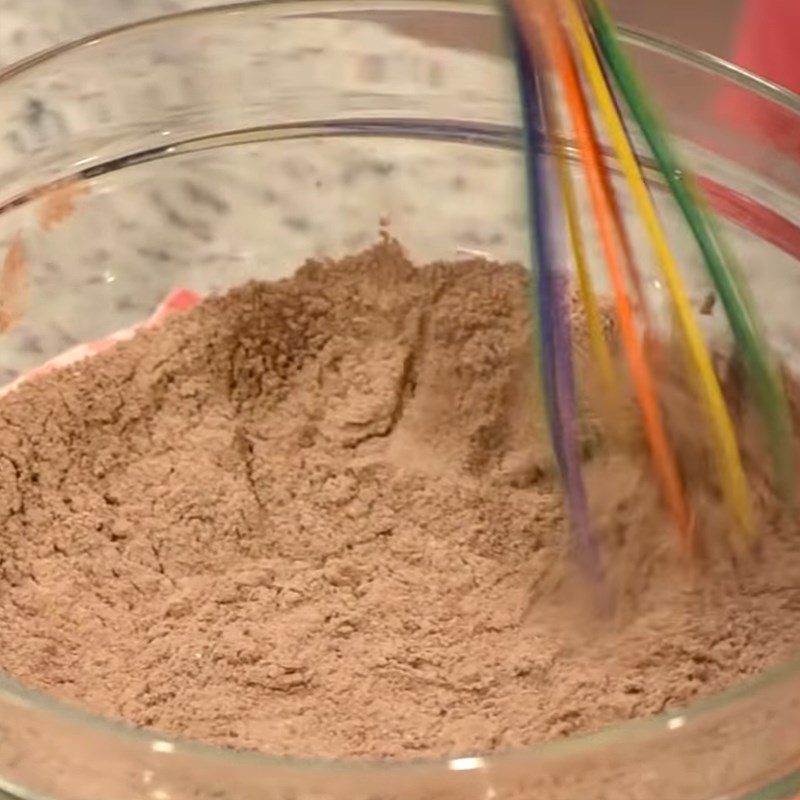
[719,0,800,159]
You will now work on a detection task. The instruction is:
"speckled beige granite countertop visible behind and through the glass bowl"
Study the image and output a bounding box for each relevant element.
[0,0,800,383]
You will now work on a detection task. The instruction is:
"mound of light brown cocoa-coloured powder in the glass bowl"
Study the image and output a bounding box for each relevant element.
[0,242,800,758]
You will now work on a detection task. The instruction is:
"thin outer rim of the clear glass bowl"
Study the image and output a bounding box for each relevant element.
[0,0,800,774]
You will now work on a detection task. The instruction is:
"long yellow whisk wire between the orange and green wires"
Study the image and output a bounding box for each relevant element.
[561,0,756,541]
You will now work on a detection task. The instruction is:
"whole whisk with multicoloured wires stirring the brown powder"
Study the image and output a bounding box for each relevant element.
[503,0,793,579]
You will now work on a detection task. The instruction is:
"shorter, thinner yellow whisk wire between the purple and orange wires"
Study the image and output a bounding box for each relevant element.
[554,124,616,397]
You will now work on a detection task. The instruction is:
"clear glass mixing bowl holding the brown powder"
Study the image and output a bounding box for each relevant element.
[0,0,800,800]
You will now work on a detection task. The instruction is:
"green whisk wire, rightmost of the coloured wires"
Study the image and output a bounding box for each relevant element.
[585,0,794,498]
